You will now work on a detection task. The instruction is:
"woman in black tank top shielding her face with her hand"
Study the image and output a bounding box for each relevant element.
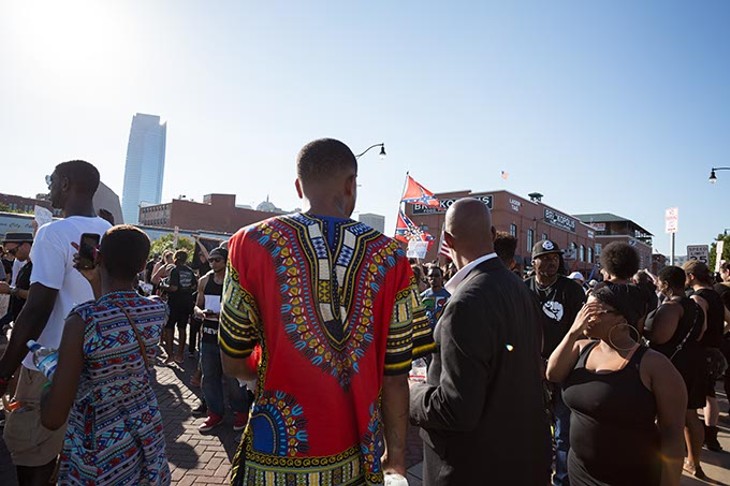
[547,285,687,486]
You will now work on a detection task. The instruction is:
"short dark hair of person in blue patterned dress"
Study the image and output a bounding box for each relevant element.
[99,224,150,280]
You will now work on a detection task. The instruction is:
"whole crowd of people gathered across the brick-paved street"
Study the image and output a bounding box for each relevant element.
[0,139,730,485]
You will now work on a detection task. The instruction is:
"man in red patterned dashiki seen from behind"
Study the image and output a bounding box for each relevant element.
[219,139,435,485]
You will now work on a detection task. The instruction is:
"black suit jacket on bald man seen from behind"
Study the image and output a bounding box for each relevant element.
[410,258,550,485]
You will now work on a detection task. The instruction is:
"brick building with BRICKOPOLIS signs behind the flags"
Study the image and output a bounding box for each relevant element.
[406,191,595,275]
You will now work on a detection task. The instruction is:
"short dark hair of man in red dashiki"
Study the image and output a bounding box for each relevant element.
[297,138,357,183]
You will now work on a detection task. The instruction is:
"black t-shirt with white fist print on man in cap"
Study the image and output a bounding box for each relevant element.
[525,276,586,358]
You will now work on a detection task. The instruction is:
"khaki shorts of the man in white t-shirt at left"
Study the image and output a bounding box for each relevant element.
[3,366,66,467]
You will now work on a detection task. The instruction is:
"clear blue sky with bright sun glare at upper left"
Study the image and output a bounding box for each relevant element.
[0,0,730,254]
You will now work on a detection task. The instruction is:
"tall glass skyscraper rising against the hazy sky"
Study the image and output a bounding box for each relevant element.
[122,113,167,224]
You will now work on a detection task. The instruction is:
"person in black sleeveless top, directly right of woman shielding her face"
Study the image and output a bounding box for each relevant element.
[644,266,706,479]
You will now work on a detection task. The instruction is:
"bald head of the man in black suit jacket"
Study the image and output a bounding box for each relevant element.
[445,198,494,266]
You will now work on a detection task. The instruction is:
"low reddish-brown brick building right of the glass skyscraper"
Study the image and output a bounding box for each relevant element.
[139,194,281,233]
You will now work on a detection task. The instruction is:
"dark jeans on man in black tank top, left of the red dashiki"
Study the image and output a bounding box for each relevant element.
[200,342,249,416]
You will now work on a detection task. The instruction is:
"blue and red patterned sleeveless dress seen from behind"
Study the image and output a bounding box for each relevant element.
[58,291,170,486]
